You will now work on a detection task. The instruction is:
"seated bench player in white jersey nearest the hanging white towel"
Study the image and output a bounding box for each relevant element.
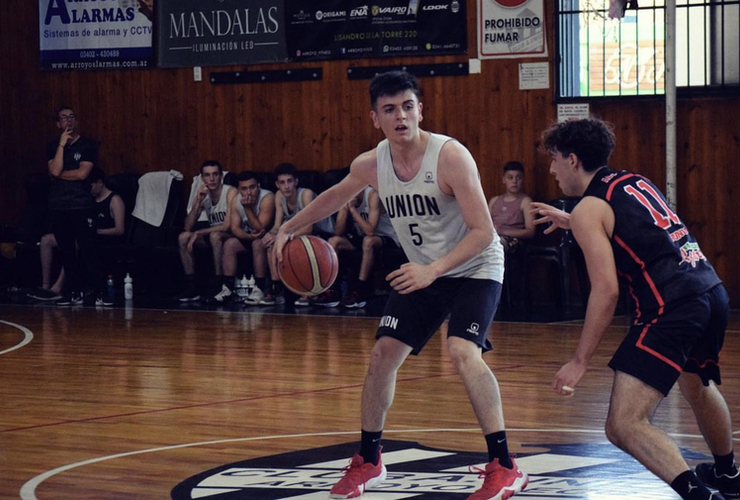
[177,160,236,302]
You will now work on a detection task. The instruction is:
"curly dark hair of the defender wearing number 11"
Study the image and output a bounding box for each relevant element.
[542,118,617,172]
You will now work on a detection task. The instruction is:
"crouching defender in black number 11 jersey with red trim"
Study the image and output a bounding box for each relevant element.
[532,119,740,500]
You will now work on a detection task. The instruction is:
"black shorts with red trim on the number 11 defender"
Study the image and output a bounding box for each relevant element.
[609,285,729,396]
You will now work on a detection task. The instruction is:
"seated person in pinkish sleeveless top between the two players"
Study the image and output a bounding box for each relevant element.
[488,161,535,253]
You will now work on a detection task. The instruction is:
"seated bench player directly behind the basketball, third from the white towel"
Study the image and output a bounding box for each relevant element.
[254,163,333,306]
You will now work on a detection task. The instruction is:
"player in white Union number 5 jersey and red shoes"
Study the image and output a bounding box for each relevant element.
[277,71,528,500]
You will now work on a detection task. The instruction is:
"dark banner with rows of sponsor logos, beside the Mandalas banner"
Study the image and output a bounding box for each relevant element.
[285,0,468,61]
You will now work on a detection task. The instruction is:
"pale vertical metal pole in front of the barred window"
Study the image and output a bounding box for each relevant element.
[665,0,676,211]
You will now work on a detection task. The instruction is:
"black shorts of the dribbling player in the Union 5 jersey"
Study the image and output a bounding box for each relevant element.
[375,278,501,355]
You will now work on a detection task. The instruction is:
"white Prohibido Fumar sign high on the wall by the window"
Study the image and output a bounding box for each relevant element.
[477,0,547,59]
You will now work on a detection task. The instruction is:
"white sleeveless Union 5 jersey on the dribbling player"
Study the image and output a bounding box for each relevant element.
[377,134,504,283]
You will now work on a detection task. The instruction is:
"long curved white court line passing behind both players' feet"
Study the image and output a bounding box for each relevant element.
[20,427,732,500]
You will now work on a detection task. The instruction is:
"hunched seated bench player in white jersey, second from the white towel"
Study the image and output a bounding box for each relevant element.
[214,172,275,303]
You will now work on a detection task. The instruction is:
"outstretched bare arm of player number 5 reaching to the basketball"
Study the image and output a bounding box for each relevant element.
[277,149,377,261]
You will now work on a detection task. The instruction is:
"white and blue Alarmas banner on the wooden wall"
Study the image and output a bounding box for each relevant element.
[39,0,153,70]
